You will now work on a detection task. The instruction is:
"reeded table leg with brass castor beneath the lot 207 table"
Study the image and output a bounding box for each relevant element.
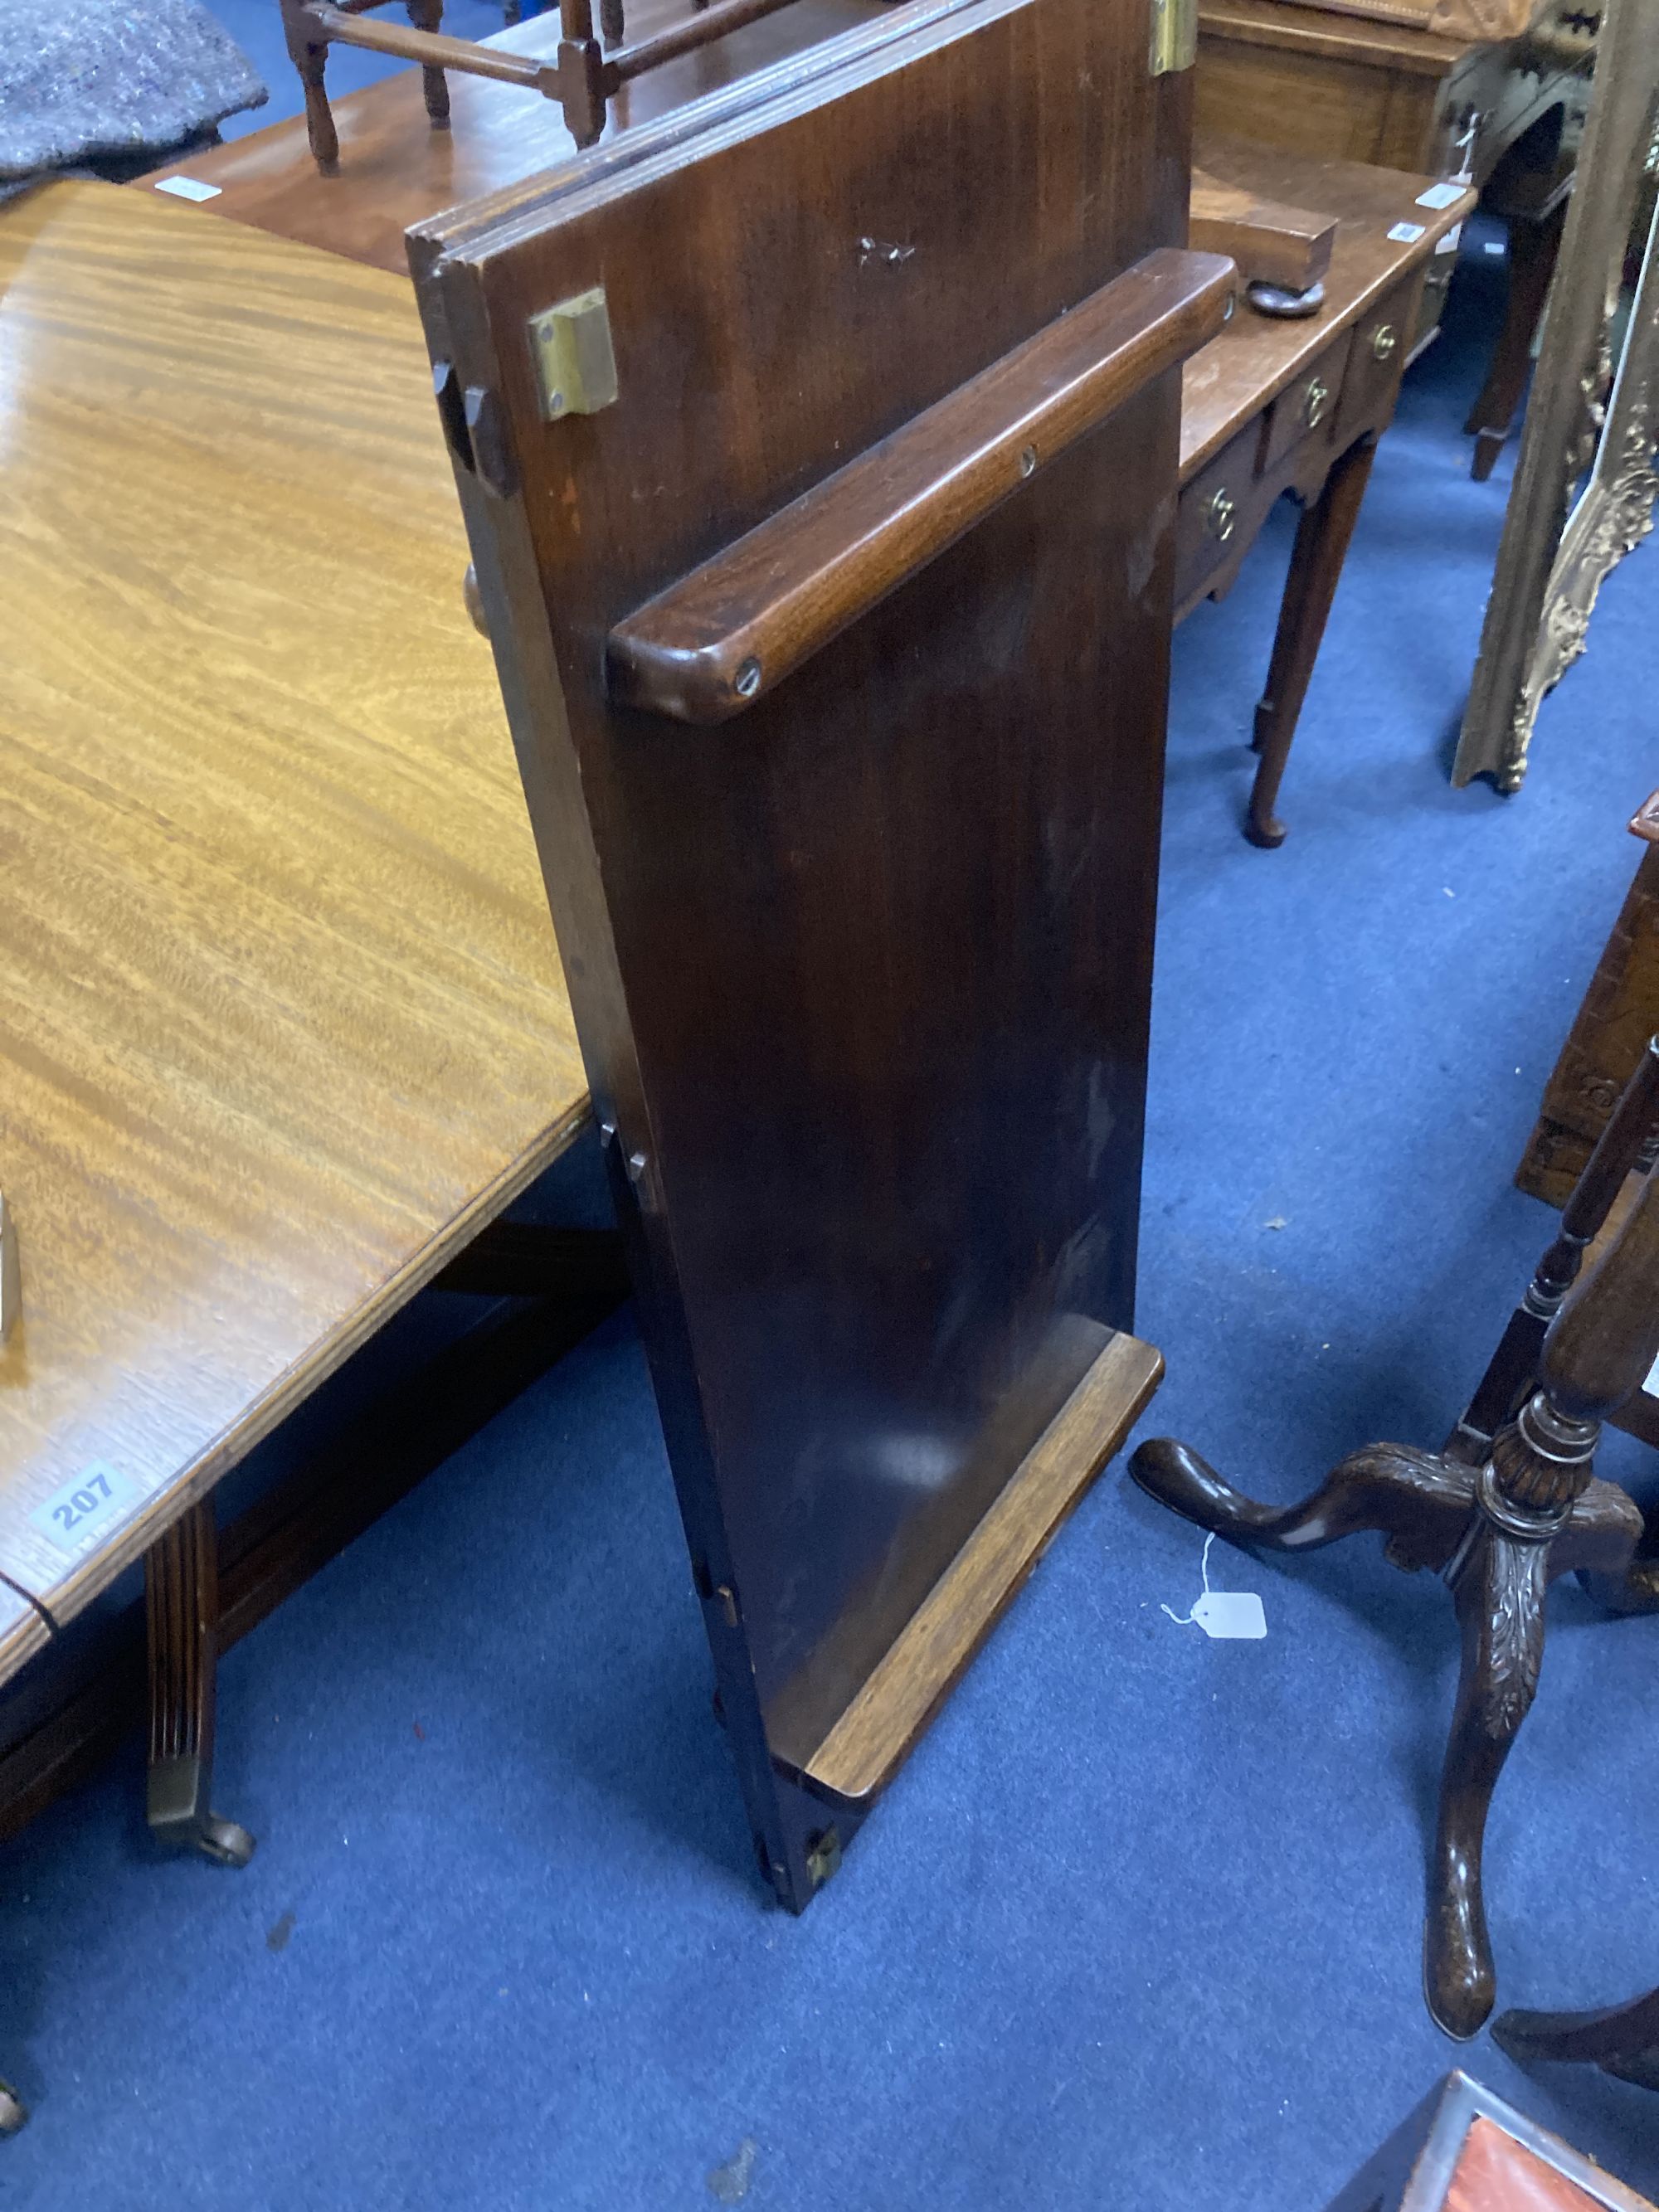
[144,1500,255,1867]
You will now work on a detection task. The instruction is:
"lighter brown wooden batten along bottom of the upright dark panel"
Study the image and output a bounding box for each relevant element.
[800,1334,1164,1805]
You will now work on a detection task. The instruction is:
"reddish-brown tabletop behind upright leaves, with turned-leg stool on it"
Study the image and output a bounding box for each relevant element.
[146,0,892,276]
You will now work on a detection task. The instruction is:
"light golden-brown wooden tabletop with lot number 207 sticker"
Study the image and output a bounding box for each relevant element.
[0,183,586,1650]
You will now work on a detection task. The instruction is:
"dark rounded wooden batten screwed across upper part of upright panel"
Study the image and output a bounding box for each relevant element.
[608,246,1237,723]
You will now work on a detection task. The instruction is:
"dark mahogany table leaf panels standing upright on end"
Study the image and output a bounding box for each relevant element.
[411,0,1190,1909]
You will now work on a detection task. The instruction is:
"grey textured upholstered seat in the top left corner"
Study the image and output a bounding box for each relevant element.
[0,0,265,188]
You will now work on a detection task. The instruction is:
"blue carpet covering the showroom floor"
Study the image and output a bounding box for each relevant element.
[12,100,1659,2212]
